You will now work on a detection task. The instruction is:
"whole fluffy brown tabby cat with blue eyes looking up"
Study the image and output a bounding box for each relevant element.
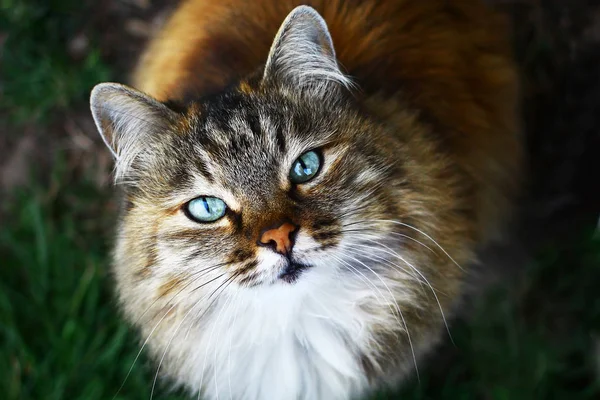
[90,0,522,400]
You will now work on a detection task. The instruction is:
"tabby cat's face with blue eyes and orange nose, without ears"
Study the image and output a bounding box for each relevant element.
[125,89,402,287]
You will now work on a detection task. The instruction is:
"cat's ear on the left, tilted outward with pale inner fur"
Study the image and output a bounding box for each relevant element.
[90,83,175,180]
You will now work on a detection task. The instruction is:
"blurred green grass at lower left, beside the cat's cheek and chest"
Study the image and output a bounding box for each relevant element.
[0,173,188,400]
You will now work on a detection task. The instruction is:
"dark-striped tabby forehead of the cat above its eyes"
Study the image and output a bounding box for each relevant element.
[174,94,323,195]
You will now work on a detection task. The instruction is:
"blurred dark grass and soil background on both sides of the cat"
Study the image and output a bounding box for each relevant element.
[0,0,600,400]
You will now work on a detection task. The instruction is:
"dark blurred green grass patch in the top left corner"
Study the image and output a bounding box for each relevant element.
[0,0,110,124]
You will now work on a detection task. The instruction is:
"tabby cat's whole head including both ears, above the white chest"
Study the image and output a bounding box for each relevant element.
[91,7,472,326]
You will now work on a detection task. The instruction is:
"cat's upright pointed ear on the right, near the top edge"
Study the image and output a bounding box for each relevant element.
[263,6,352,92]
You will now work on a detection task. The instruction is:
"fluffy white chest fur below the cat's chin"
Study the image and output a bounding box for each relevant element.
[164,269,398,400]
